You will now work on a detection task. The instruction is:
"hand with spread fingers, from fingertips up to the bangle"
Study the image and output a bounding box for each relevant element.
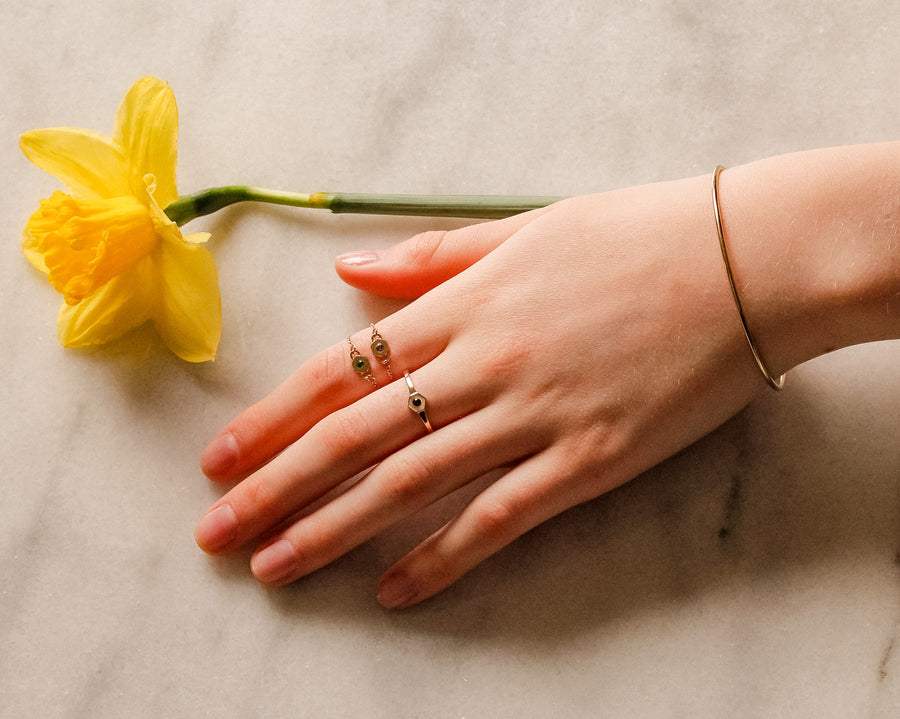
[196,176,764,607]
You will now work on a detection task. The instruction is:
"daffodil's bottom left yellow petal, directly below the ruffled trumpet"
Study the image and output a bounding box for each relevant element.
[56,257,156,347]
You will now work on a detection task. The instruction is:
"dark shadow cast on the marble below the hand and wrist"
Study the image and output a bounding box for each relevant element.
[234,354,900,647]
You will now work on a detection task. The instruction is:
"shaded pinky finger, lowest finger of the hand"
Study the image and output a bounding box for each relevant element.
[378,450,580,609]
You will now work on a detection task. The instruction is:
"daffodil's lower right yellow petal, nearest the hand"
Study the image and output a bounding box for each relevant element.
[154,239,222,362]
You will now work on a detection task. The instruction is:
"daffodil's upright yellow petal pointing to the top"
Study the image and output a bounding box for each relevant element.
[113,77,178,207]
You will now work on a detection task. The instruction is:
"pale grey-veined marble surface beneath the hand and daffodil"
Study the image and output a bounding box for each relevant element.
[0,0,900,719]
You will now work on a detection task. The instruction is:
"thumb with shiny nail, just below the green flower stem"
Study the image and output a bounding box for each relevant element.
[335,207,548,299]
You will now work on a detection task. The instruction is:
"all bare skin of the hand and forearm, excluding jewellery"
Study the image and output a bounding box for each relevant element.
[195,144,900,608]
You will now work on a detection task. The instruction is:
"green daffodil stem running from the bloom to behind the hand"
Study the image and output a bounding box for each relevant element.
[166,185,563,226]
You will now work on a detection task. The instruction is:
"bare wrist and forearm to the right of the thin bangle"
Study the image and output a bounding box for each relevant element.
[719,143,900,374]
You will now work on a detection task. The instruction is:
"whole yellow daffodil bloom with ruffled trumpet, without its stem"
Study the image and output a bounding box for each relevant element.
[19,77,222,362]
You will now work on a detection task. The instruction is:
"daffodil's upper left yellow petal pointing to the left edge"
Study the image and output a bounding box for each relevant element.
[19,127,131,198]
